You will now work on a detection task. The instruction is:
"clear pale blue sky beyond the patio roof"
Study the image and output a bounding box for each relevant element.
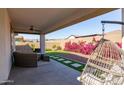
[20,9,121,39]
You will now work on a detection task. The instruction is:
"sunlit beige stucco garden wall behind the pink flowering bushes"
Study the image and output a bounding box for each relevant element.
[46,30,121,49]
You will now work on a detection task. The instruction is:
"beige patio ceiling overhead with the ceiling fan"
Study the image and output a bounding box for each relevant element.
[8,8,114,34]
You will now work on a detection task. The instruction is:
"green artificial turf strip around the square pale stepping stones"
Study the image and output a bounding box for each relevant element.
[47,52,85,72]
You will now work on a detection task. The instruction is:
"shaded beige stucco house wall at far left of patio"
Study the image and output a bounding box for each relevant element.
[0,9,11,83]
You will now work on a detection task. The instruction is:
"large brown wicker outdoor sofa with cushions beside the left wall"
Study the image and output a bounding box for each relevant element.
[13,45,40,67]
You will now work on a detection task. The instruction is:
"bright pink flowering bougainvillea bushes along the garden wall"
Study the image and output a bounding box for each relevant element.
[64,37,122,55]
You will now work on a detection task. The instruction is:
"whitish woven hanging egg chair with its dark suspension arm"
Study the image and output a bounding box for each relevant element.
[77,21,124,85]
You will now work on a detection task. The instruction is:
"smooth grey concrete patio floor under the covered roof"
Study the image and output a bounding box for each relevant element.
[9,60,81,85]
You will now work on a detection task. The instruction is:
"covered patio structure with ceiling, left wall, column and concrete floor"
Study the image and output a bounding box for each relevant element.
[0,8,124,85]
